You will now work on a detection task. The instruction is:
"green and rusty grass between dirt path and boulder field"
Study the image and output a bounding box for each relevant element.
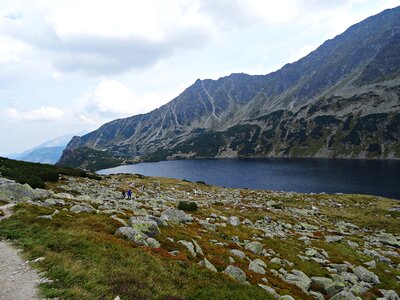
[0,204,268,299]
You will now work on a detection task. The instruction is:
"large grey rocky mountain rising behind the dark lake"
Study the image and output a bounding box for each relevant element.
[60,7,400,168]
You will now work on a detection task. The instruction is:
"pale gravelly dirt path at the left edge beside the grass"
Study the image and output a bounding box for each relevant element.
[0,204,40,300]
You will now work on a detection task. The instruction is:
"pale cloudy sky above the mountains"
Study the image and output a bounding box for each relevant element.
[0,0,400,155]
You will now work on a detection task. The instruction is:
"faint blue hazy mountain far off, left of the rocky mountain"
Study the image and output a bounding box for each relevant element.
[12,134,82,164]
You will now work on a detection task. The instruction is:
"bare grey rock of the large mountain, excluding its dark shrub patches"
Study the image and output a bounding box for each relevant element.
[60,7,400,170]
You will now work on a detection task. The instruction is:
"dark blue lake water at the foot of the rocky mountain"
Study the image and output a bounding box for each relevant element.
[98,158,400,199]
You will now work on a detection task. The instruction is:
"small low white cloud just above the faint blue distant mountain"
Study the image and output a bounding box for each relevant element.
[5,106,64,122]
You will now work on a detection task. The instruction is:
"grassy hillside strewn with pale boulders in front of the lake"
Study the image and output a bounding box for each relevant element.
[0,163,400,300]
